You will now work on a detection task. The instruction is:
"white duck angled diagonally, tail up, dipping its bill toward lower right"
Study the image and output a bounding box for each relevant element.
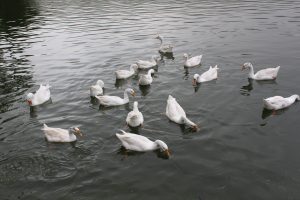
[166,95,197,131]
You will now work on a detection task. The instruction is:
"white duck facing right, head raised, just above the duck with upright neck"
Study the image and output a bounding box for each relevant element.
[95,88,135,106]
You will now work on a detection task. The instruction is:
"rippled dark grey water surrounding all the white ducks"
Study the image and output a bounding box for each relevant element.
[0,0,300,200]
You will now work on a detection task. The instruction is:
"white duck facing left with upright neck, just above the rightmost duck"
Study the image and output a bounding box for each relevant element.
[242,62,280,80]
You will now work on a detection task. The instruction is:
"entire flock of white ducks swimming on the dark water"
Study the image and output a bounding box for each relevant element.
[26,35,300,157]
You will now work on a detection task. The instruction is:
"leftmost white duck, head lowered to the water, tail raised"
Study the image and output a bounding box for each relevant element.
[26,84,51,106]
